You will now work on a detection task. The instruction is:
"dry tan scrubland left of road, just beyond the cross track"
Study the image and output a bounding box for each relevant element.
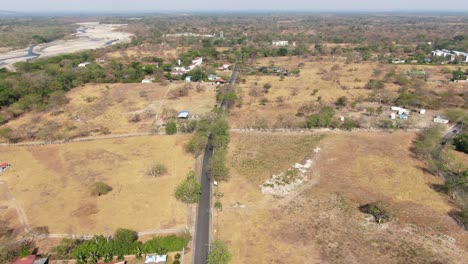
[0,82,216,140]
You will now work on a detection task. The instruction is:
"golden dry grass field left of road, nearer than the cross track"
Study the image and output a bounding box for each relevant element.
[0,136,195,234]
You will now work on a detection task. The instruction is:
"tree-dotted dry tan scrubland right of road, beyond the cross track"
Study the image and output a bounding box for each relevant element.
[230,57,466,127]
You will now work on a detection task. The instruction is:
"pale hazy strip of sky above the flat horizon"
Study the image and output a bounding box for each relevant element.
[0,0,468,12]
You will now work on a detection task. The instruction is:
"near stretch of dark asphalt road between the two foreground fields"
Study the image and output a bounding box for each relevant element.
[194,137,213,264]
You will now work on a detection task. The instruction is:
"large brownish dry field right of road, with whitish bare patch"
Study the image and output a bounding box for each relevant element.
[218,132,468,263]
